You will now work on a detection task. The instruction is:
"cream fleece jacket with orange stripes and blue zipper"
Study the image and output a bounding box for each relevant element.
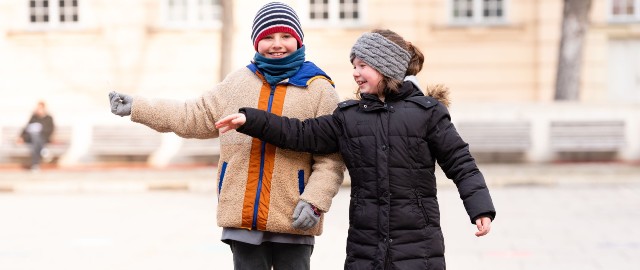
[131,68,345,235]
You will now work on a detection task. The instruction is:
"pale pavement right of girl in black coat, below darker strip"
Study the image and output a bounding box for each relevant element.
[439,184,640,270]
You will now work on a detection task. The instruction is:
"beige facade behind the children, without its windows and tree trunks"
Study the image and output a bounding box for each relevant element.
[0,0,640,113]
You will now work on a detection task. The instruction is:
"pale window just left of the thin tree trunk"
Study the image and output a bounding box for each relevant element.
[163,0,222,26]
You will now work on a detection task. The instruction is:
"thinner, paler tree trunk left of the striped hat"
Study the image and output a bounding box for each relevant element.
[220,0,234,81]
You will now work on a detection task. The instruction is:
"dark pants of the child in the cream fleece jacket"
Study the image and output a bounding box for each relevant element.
[229,241,313,270]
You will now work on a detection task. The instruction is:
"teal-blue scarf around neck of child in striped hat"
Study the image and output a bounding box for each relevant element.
[253,46,305,85]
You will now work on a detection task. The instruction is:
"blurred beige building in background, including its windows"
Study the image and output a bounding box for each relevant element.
[0,0,640,163]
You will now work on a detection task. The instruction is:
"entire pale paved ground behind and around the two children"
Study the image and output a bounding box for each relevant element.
[0,164,640,270]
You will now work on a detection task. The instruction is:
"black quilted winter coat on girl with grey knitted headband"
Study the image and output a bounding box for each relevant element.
[238,82,496,270]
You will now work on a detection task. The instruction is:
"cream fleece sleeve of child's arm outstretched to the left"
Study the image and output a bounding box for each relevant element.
[131,87,224,139]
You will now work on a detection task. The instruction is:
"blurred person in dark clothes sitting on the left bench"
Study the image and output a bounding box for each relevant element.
[16,101,55,171]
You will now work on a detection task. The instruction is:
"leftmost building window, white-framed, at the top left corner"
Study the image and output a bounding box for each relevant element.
[29,0,78,25]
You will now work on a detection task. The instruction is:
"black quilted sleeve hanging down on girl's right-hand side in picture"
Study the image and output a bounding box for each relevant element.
[428,103,496,224]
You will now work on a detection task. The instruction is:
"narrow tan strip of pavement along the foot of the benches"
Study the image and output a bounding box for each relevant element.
[0,163,640,192]
